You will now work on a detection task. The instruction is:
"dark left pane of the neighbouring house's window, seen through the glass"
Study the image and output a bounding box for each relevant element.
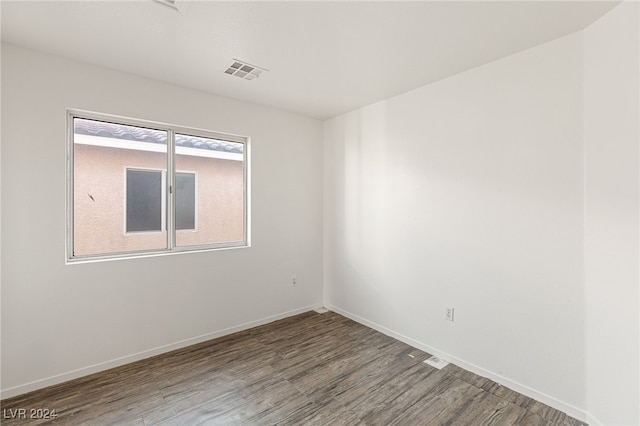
[127,170,163,232]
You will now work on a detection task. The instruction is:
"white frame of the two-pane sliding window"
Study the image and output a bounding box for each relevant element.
[65,109,251,264]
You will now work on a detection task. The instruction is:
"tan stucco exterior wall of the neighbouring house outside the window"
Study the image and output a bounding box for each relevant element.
[73,144,244,256]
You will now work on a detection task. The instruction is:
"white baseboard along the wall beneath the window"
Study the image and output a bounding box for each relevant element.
[0,304,322,400]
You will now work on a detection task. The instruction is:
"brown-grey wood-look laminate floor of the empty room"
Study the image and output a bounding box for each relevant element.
[1,312,583,426]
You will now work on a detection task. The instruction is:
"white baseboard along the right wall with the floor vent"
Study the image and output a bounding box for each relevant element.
[325,303,600,426]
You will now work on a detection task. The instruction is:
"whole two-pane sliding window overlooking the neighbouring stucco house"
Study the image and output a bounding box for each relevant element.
[67,111,249,261]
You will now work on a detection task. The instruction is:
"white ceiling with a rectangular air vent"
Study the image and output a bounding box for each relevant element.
[1,0,617,119]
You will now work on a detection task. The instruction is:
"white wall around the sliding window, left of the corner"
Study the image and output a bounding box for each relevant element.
[2,45,322,397]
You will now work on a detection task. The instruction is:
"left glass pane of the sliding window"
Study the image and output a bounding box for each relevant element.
[73,118,167,256]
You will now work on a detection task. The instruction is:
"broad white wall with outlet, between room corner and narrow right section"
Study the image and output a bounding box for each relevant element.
[324,34,585,417]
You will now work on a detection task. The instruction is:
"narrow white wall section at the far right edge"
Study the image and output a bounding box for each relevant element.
[584,1,640,425]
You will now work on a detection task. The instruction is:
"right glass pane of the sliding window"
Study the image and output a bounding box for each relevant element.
[175,134,245,246]
